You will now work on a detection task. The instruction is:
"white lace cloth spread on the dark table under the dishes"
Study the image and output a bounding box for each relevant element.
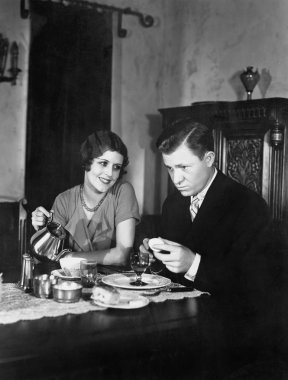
[0,283,208,324]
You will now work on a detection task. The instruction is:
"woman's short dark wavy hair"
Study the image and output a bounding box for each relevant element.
[80,130,129,178]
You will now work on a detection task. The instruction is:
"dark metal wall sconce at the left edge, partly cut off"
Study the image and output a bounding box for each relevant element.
[0,34,21,86]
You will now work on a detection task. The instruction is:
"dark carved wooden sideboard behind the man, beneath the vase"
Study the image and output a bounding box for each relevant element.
[159,98,288,222]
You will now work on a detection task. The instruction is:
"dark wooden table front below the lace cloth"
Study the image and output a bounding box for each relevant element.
[0,299,209,379]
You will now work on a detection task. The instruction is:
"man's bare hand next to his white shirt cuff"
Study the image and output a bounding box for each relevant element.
[151,238,195,273]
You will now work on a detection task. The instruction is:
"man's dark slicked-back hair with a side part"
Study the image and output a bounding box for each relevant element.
[156,119,214,160]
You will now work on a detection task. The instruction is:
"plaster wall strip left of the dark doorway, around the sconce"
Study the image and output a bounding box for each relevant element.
[0,0,30,202]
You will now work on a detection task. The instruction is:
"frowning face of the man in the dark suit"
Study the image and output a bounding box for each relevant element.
[162,144,215,197]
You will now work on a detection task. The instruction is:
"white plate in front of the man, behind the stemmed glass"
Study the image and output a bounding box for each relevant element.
[102,273,171,290]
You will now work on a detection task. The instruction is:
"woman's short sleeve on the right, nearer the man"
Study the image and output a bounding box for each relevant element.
[115,182,140,225]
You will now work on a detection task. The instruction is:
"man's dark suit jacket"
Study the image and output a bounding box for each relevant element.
[161,171,271,310]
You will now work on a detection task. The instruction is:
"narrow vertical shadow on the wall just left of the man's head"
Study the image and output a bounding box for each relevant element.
[143,114,162,214]
